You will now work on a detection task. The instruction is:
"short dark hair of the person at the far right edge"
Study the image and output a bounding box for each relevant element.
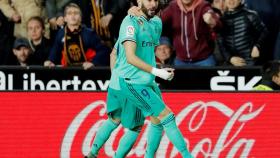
[263,60,280,80]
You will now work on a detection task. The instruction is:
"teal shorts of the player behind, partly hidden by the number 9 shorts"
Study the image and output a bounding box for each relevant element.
[107,88,145,129]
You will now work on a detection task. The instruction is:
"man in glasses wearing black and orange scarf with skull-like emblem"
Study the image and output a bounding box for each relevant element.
[44,3,110,69]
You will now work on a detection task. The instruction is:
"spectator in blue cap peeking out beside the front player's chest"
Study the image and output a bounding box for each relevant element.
[155,37,173,68]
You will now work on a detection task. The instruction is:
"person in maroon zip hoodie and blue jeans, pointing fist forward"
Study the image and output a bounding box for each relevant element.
[161,0,221,66]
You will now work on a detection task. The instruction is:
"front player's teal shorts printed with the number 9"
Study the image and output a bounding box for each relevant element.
[120,78,166,117]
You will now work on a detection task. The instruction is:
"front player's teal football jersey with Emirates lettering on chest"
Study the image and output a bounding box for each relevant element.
[115,15,162,84]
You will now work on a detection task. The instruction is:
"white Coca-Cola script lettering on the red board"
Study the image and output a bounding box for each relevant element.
[60,100,265,158]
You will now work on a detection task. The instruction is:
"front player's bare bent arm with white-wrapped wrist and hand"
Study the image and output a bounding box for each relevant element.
[123,40,174,80]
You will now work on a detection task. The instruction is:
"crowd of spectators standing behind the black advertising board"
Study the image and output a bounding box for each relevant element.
[0,0,280,69]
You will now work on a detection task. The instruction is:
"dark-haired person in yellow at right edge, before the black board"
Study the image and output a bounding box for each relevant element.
[254,61,280,91]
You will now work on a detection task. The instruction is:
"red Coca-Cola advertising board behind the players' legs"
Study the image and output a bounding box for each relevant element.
[0,92,280,158]
